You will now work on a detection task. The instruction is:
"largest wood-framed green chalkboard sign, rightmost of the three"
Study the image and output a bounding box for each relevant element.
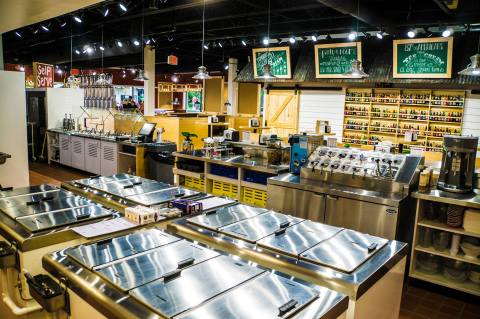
[393,37,453,78]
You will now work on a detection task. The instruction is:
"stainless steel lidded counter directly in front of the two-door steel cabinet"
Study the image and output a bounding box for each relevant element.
[167,205,408,300]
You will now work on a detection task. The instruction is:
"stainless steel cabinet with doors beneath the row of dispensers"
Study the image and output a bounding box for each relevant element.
[267,149,422,242]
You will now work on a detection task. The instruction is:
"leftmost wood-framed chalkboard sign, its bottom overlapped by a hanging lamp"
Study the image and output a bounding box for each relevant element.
[253,47,292,79]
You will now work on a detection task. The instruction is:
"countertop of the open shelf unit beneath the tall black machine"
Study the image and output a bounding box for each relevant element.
[412,189,480,209]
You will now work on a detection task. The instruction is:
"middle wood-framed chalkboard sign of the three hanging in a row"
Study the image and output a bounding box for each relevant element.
[315,42,362,78]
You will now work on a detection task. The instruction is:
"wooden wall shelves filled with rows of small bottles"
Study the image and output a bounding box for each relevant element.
[343,88,466,152]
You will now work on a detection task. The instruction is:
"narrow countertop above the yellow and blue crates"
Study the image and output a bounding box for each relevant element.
[172,152,289,174]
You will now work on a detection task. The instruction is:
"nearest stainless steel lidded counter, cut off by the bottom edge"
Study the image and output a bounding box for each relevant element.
[43,229,348,319]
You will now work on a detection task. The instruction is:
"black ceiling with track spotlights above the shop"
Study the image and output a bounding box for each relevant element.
[3,0,480,73]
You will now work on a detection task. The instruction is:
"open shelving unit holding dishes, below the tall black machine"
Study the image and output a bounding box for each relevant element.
[409,194,480,296]
